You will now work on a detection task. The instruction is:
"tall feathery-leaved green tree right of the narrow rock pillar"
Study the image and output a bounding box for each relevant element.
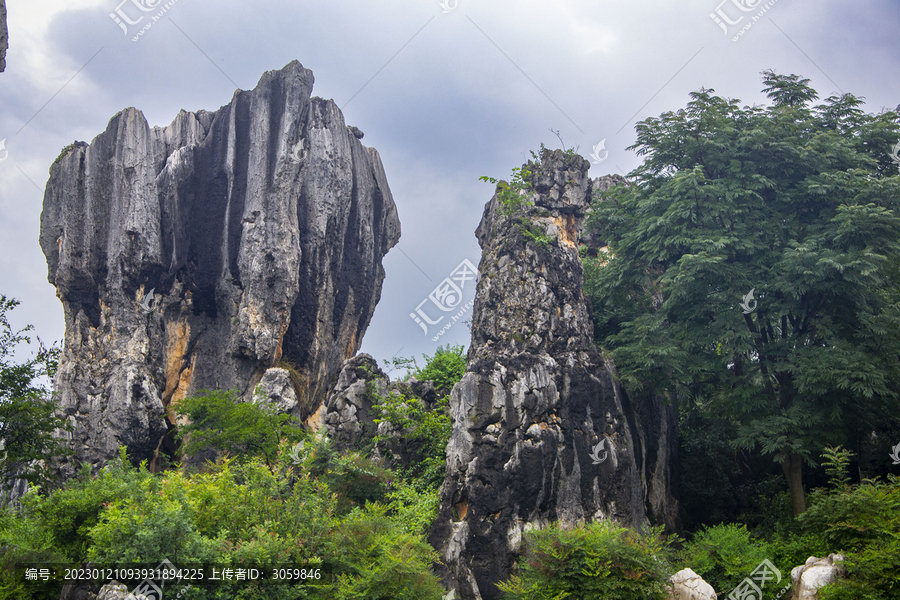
[586,71,900,515]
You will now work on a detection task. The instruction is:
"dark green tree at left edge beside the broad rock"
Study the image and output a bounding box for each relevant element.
[0,295,70,486]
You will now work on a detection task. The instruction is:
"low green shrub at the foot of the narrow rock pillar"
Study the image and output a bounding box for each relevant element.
[499,521,671,600]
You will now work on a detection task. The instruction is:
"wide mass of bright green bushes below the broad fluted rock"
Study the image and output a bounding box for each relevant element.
[0,443,443,599]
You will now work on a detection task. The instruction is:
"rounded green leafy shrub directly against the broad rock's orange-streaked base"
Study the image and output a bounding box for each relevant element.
[175,390,304,465]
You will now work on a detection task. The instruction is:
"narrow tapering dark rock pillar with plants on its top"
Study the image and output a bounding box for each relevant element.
[430,151,674,600]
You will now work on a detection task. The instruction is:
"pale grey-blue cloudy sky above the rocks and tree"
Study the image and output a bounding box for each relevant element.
[0,0,900,376]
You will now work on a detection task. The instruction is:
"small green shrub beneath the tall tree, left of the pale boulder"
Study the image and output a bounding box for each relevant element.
[679,524,768,593]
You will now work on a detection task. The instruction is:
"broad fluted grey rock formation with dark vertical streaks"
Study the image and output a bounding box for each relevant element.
[40,61,400,474]
